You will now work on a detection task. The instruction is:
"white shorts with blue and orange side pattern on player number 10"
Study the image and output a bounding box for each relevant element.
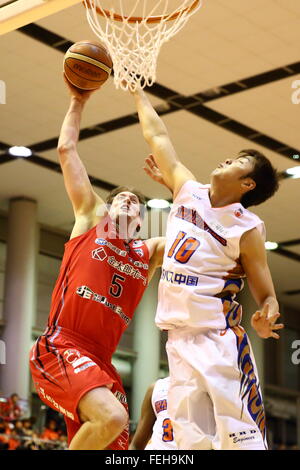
[167,326,267,450]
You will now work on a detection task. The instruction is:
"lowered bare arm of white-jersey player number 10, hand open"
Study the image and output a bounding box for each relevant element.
[240,228,284,339]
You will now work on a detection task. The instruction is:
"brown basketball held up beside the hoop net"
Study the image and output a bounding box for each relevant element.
[64,40,113,90]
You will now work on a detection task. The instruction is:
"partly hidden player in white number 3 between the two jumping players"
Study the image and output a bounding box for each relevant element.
[129,377,177,450]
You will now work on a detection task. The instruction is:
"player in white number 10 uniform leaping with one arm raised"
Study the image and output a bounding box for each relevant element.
[134,90,283,450]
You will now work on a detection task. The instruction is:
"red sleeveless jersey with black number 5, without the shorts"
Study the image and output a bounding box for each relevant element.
[47,226,149,354]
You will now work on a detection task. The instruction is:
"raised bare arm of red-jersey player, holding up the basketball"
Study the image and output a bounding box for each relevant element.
[57,79,104,225]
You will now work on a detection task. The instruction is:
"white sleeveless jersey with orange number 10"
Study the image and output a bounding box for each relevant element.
[155,181,265,330]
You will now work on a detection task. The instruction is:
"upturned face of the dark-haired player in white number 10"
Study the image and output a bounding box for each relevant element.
[212,154,254,181]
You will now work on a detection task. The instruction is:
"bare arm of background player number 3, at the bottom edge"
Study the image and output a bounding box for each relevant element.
[129,384,156,450]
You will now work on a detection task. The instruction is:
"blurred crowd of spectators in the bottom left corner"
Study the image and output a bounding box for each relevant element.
[0,393,67,450]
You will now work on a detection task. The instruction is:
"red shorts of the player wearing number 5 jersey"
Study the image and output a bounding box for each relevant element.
[30,327,129,450]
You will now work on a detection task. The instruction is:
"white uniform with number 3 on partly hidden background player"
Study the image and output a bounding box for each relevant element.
[145,377,177,450]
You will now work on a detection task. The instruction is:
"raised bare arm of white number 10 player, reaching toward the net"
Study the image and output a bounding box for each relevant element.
[134,89,195,199]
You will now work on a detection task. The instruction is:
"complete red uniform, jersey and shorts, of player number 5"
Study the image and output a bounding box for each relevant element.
[30,220,149,450]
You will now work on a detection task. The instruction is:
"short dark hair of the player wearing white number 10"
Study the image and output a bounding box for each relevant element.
[239,149,279,207]
